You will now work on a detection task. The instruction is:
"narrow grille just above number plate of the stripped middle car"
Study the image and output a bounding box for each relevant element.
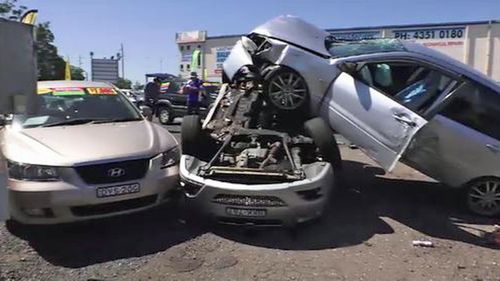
[212,194,286,207]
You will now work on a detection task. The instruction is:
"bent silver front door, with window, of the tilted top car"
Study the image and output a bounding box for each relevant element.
[321,60,451,171]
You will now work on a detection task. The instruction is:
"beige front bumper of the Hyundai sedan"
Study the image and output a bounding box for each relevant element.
[8,162,179,224]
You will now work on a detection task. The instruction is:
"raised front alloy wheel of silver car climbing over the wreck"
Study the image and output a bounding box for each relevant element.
[261,65,309,112]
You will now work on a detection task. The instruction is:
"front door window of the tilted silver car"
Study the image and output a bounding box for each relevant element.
[356,62,452,113]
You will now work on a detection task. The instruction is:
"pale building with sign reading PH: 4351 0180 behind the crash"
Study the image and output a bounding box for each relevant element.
[176,21,500,82]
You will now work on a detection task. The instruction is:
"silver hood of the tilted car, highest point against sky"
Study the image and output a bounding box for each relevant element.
[251,15,330,57]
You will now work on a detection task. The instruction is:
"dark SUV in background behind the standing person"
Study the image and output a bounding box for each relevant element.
[157,81,219,125]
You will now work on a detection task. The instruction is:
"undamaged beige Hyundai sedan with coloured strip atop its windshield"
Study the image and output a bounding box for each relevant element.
[1,81,179,224]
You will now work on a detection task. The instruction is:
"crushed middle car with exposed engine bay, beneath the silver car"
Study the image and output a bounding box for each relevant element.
[179,81,340,227]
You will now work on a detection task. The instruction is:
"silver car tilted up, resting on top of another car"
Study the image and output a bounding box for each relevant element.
[224,16,500,216]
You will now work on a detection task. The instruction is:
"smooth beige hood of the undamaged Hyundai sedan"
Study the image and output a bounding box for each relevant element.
[2,121,177,166]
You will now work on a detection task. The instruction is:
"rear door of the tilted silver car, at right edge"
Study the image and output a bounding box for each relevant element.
[404,81,500,187]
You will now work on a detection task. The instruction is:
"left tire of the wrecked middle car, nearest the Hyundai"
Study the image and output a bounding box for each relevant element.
[181,115,204,157]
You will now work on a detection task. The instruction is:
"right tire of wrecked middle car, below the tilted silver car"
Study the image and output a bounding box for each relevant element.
[304,117,342,171]
